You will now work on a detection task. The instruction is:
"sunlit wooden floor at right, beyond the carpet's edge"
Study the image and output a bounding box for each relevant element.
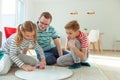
[91,51,120,80]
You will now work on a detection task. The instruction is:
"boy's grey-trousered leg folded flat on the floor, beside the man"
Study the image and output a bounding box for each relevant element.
[57,53,74,66]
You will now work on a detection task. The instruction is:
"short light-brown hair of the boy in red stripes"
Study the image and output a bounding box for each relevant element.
[65,20,80,31]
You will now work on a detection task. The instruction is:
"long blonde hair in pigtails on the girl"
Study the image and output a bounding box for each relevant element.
[15,21,37,46]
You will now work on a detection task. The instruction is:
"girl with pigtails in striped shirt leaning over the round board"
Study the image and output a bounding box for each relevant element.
[0,21,46,74]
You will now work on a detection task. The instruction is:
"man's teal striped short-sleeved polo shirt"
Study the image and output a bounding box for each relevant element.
[37,26,58,51]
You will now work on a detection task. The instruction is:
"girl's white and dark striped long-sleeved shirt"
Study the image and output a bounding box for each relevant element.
[2,34,44,67]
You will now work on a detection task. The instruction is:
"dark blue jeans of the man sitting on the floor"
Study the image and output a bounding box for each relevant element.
[37,47,68,65]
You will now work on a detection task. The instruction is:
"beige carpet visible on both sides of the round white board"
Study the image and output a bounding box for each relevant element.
[0,58,108,80]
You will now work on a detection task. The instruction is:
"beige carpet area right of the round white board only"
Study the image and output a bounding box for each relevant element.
[65,59,108,80]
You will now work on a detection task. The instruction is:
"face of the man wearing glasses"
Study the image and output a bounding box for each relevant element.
[38,16,51,31]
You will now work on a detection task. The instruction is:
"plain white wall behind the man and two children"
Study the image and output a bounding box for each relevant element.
[26,0,120,49]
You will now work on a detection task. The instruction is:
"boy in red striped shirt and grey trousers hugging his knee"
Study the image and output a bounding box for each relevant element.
[57,20,90,69]
